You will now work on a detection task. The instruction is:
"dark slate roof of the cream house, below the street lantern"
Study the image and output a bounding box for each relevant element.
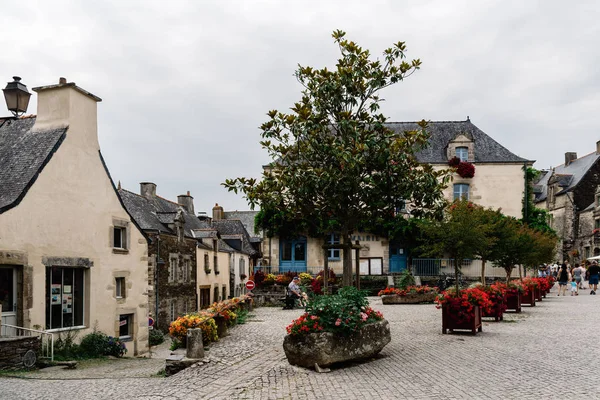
[0,117,68,213]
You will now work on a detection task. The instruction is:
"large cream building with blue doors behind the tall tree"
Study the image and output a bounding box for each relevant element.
[263,119,533,275]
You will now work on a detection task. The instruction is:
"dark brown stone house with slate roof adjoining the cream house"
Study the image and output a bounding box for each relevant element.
[119,182,200,331]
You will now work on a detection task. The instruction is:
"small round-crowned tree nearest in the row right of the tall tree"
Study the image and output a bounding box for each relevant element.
[421,199,489,293]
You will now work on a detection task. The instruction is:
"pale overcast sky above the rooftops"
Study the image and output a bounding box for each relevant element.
[0,0,600,212]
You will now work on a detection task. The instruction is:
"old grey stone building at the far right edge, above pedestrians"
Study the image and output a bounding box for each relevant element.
[534,145,600,262]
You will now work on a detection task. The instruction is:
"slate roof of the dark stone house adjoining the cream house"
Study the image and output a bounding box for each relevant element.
[118,189,202,238]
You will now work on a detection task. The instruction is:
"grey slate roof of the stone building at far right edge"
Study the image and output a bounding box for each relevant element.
[535,152,600,202]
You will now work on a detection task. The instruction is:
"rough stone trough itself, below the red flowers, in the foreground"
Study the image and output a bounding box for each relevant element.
[283,319,391,368]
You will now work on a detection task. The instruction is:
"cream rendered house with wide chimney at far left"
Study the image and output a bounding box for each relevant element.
[0,78,148,355]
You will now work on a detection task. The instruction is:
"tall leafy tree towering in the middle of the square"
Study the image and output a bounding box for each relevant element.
[223,30,449,286]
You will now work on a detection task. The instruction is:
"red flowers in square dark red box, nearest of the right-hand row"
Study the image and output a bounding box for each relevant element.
[435,288,491,334]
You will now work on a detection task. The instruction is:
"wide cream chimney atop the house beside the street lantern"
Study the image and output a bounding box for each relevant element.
[32,78,102,151]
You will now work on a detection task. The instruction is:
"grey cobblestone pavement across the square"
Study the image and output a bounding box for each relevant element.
[0,289,600,400]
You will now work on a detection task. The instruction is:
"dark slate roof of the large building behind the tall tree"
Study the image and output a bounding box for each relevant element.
[386,120,533,164]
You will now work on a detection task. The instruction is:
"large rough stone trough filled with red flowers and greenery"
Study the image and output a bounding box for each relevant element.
[283,287,391,368]
